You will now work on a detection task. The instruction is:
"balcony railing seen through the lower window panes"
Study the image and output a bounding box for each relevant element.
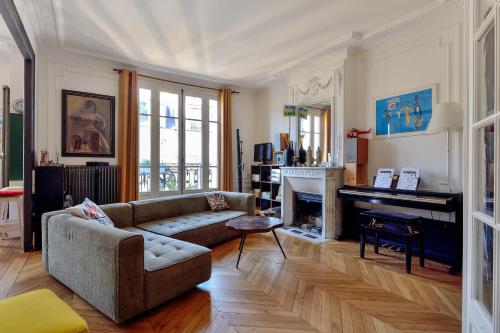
[139,163,217,192]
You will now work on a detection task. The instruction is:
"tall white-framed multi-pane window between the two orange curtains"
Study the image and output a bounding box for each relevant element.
[139,82,220,197]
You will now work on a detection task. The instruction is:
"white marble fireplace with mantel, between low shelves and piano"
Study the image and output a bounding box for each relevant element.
[281,167,344,241]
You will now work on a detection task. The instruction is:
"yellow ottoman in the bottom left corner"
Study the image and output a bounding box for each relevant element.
[0,289,88,333]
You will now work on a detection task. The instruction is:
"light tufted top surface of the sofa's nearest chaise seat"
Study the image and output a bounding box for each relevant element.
[125,227,211,271]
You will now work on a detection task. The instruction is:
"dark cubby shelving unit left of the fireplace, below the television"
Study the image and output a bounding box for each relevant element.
[251,164,281,210]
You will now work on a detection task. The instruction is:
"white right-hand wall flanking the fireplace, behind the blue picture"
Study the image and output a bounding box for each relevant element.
[256,13,464,191]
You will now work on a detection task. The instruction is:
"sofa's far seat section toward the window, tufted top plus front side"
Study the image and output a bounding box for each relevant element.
[137,210,246,246]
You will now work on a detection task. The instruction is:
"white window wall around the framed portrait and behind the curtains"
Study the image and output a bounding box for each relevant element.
[35,53,255,188]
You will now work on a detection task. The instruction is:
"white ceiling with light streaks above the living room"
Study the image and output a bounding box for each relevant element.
[16,0,446,85]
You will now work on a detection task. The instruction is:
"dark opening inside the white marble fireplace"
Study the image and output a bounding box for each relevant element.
[291,192,323,238]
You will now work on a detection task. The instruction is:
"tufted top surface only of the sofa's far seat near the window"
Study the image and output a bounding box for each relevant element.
[137,210,246,238]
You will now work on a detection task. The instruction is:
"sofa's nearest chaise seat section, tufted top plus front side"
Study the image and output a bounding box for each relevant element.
[125,227,212,309]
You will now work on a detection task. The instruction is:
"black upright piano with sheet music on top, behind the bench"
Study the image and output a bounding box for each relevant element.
[337,186,463,274]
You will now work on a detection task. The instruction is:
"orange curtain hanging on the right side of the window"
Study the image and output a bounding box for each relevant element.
[219,88,233,191]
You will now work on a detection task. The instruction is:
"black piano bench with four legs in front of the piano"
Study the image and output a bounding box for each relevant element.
[359,210,425,274]
